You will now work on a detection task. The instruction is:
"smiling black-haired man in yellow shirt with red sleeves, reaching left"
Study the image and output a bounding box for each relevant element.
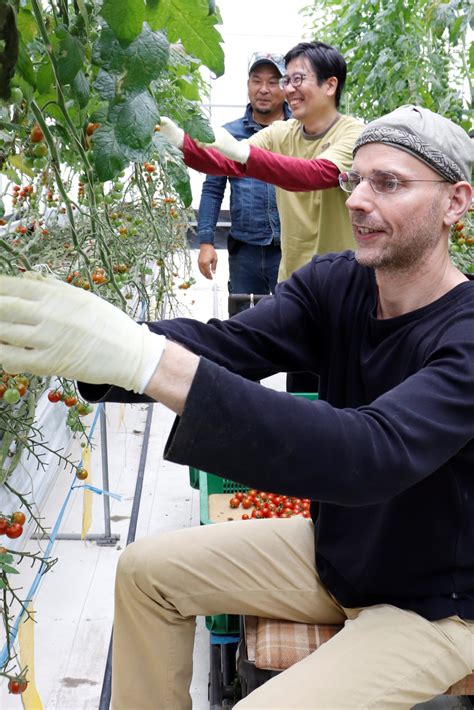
[162,42,362,281]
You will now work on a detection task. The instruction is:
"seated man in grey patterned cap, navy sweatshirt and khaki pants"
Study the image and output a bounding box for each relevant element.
[0,106,474,710]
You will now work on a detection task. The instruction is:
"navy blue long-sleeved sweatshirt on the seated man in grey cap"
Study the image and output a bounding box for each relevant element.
[81,252,474,620]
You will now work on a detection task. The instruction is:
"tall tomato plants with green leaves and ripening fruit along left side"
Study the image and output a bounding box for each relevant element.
[0,0,224,692]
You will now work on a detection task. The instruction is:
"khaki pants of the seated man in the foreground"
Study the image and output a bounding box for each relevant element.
[112,518,474,710]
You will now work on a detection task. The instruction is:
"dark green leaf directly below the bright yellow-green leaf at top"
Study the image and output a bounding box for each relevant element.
[124,25,169,89]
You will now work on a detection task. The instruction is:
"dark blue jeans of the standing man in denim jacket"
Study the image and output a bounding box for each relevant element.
[227,237,281,310]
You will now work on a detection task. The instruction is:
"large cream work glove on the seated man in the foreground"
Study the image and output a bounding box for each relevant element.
[0,272,166,394]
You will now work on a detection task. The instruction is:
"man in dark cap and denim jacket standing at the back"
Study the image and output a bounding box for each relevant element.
[198,52,291,308]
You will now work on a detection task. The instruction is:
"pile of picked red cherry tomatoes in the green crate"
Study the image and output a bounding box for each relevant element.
[229,488,311,520]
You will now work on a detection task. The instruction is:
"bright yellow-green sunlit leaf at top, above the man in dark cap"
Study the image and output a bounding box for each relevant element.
[146,0,224,76]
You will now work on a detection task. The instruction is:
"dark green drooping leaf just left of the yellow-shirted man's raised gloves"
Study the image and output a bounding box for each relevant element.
[115,91,159,160]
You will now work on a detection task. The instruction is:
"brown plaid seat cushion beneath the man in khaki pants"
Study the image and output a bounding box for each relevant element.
[245,616,474,695]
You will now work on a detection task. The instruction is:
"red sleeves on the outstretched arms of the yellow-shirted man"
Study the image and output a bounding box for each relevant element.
[183,134,339,192]
